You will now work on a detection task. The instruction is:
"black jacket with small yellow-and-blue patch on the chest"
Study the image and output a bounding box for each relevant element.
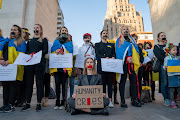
[95,41,115,73]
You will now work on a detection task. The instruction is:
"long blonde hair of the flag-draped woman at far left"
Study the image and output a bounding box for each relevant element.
[10,25,24,46]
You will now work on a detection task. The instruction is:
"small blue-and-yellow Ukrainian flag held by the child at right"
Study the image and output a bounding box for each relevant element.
[167,60,180,72]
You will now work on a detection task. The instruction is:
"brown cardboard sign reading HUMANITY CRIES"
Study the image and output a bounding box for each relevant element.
[75,85,104,109]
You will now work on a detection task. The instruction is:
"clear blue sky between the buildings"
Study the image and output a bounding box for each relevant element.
[59,0,152,47]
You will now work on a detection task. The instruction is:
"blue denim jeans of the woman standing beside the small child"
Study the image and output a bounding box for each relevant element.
[160,65,170,100]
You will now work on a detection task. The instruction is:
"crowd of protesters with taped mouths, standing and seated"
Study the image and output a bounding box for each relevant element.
[0,24,180,115]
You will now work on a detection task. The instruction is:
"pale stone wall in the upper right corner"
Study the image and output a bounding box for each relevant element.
[148,0,180,43]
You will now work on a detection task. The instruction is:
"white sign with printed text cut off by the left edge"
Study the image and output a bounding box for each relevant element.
[0,64,17,81]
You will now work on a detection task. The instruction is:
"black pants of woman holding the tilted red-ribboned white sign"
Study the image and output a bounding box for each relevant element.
[25,64,45,103]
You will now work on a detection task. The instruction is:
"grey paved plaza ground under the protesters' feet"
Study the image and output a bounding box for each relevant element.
[0,93,180,120]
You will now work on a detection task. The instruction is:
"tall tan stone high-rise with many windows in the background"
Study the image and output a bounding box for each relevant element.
[103,0,144,40]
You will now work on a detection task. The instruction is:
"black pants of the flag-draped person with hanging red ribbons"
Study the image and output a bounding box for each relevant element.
[119,61,138,101]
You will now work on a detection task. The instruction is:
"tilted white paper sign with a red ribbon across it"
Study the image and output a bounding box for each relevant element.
[14,51,42,65]
